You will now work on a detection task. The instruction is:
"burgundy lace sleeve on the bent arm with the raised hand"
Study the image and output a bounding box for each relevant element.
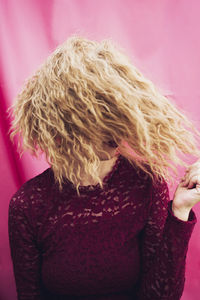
[137,180,197,300]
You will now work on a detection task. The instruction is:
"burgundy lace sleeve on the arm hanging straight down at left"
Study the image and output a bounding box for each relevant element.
[8,188,43,300]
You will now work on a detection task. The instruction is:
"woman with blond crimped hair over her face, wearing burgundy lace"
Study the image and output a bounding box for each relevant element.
[9,36,200,300]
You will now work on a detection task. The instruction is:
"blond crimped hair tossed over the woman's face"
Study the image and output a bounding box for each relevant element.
[9,35,200,195]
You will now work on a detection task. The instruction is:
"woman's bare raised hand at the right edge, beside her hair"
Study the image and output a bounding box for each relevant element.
[172,159,200,212]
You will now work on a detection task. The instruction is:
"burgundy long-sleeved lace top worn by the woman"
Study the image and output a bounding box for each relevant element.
[9,155,197,300]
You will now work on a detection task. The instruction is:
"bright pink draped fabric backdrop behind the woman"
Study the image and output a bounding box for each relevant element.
[0,0,200,300]
